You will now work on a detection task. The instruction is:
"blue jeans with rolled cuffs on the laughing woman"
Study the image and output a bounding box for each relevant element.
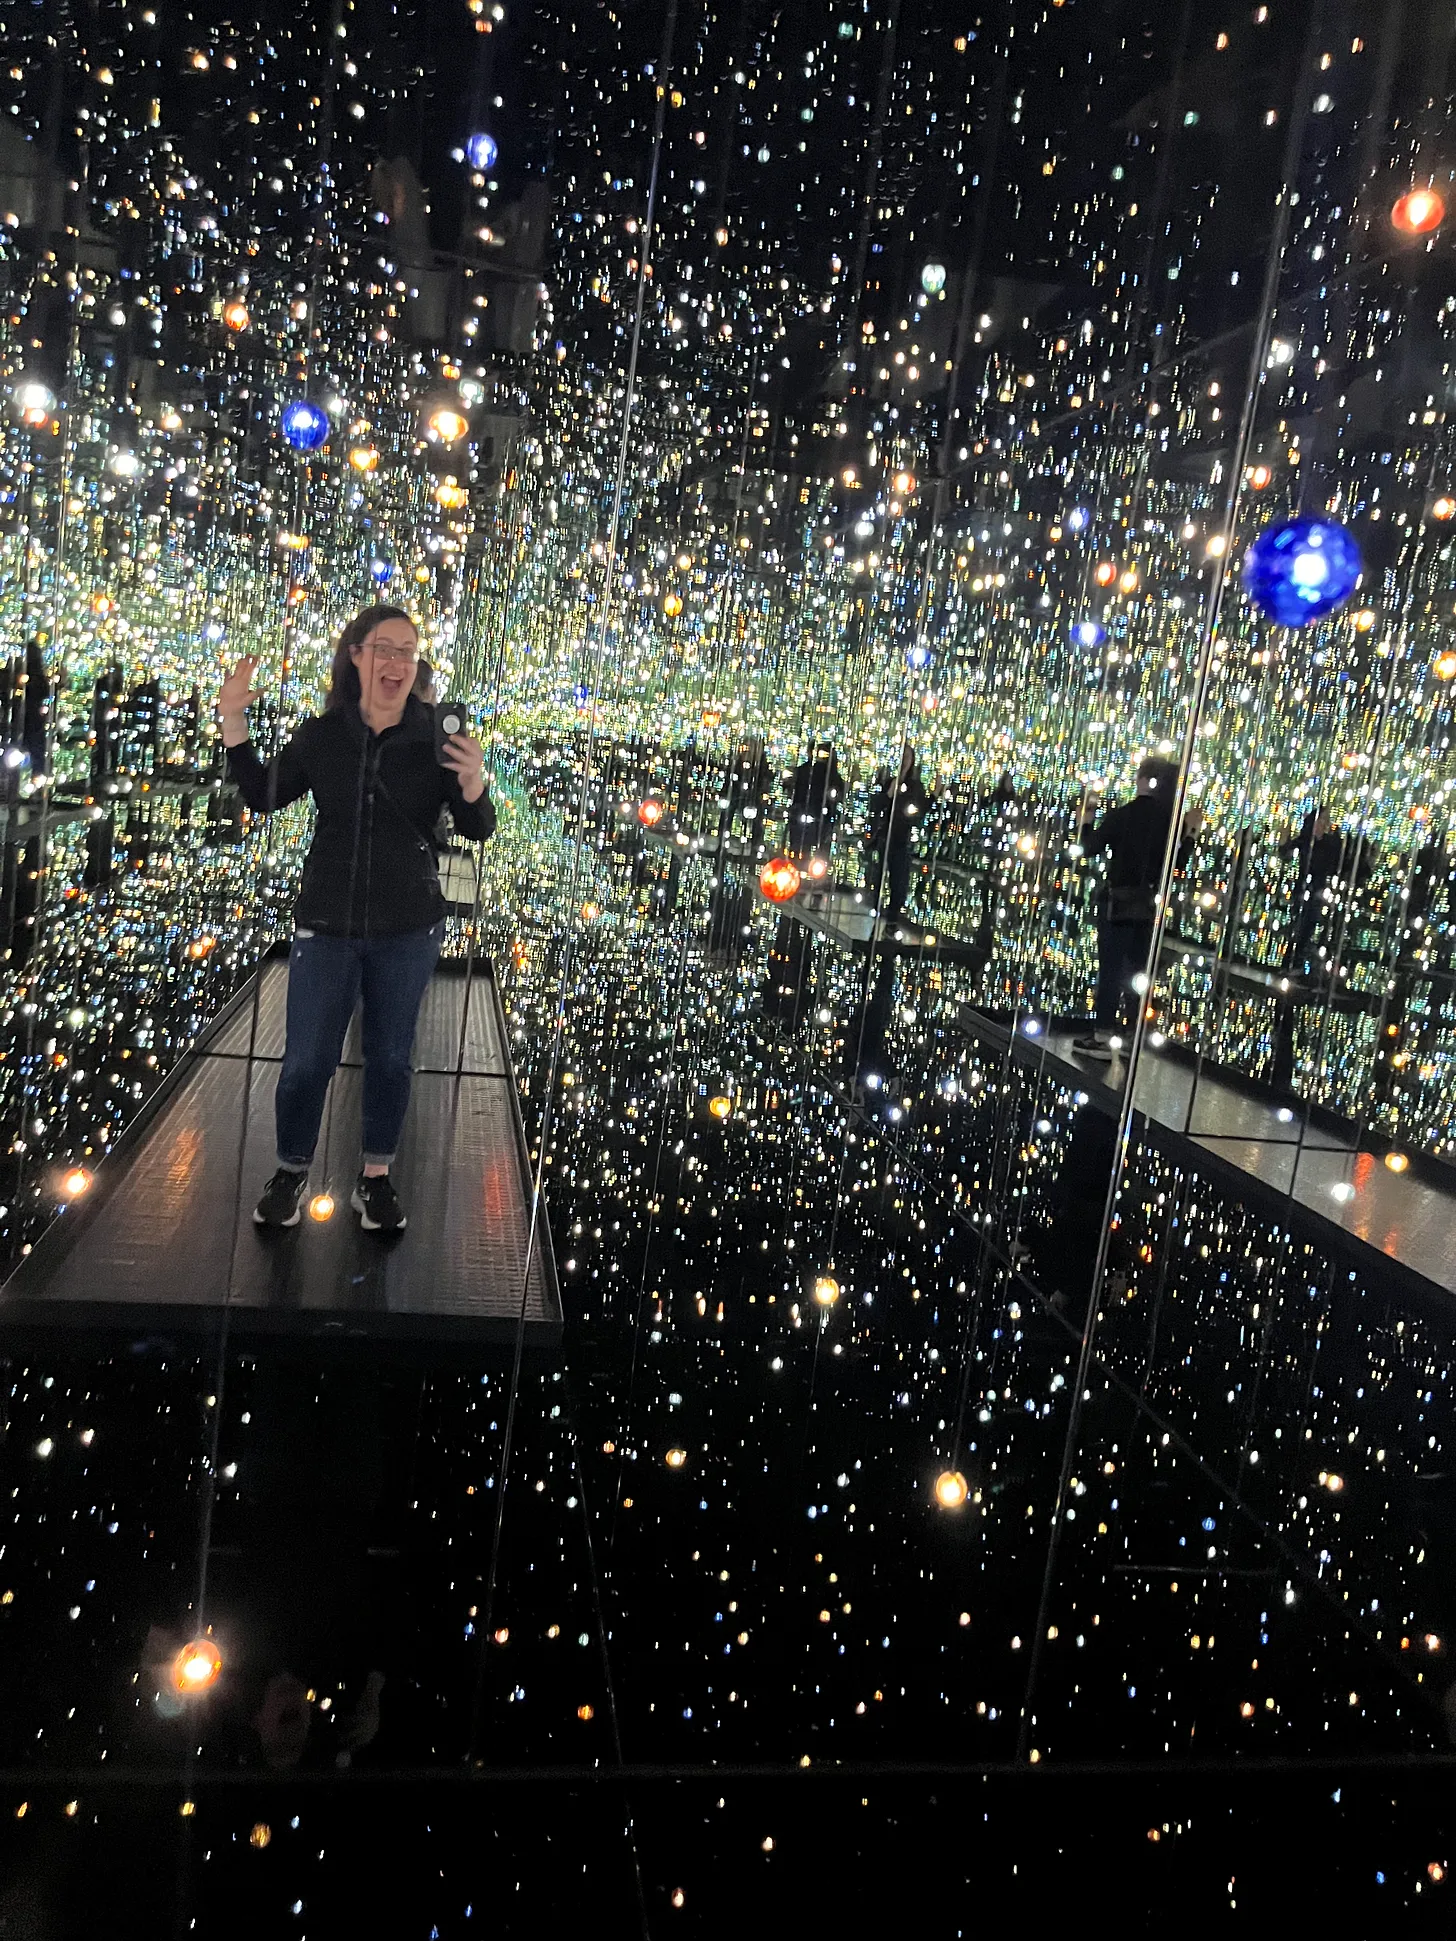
[274,924,445,1172]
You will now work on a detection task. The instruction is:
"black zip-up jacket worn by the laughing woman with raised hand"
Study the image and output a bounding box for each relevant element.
[227,695,495,938]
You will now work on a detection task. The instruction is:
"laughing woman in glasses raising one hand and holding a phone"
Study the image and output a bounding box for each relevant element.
[219,606,495,1233]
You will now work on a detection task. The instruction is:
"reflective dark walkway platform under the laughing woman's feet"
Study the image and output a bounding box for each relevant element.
[0,961,561,1349]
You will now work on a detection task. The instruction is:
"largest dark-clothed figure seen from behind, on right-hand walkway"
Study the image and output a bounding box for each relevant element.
[1072,755,1202,1058]
